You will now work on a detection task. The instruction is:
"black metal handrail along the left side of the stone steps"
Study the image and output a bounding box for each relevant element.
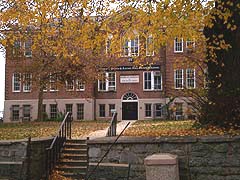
[45,112,72,179]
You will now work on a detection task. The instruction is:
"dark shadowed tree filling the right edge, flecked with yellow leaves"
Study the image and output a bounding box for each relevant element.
[201,0,240,126]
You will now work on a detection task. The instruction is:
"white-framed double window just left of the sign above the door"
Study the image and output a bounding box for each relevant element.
[98,72,116,91]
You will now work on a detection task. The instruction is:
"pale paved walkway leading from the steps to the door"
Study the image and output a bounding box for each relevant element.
[88,120,136,139]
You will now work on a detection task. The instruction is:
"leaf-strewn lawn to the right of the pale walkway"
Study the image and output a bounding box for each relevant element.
[124,120,240,137]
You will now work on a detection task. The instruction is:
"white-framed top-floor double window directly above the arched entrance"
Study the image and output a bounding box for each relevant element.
[121,35,140,57]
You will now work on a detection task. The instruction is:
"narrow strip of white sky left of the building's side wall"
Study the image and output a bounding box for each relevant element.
[0,51,5,117]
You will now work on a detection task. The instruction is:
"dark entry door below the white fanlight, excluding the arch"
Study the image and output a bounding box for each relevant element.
[122,102,138,120]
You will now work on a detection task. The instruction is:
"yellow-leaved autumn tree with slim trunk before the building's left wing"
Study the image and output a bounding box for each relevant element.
[0,0,114,120]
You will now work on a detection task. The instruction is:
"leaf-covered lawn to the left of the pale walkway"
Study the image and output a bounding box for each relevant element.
[0,121,110,140]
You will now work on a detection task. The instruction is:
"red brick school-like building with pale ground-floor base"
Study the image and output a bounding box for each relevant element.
[4,37,204,122]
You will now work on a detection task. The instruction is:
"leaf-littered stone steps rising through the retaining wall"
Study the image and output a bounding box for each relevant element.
[56,139,88,180]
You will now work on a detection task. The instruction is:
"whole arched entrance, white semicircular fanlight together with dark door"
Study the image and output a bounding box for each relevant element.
[122,92,138,120]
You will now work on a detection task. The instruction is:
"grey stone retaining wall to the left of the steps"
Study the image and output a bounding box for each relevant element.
[0,138,52,180]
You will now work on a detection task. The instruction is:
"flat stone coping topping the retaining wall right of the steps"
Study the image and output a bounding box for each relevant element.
[87,136,240,145]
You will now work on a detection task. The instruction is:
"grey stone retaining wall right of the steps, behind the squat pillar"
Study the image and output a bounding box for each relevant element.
[88,136,240,180]
